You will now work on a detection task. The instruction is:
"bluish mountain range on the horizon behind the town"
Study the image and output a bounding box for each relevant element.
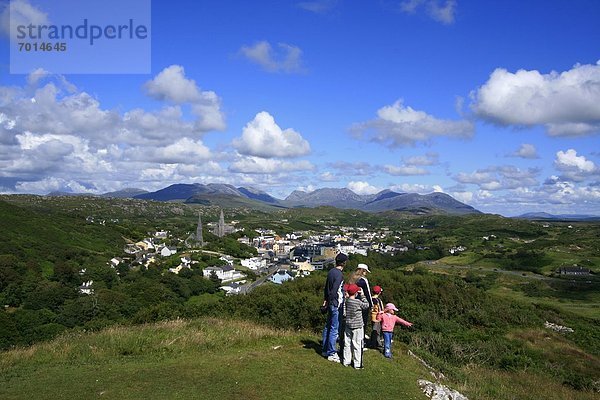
[132,183,479,214]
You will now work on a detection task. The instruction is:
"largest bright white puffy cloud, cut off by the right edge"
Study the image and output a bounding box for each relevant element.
[471,62,600,136]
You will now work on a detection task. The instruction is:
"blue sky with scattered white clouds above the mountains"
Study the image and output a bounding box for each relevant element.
[0,0,600,216]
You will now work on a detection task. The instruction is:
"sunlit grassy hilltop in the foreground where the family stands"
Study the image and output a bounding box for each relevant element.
[0,319,597,400]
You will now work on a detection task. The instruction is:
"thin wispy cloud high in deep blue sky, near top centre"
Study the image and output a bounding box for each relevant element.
[240,41,303,73]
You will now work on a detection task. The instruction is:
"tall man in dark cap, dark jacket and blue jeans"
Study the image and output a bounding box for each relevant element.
[321,253,348,363]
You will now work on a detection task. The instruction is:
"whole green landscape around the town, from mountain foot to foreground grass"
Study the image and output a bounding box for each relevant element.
[0,196,600,400]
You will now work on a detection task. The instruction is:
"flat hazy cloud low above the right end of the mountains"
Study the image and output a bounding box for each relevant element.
[454,166,540,191]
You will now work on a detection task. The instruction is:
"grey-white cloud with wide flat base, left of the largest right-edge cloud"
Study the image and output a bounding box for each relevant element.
[351,100,475,147]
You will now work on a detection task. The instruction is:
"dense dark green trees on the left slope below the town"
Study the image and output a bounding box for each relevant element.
[0,255,220,349]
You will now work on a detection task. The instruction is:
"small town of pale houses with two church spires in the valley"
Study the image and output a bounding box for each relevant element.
[88,210,426,295]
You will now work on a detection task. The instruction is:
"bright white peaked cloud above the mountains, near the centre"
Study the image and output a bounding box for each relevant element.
[233,111,310,158]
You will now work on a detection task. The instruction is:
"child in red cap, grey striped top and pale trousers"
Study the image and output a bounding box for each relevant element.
[343,283,369,369]
